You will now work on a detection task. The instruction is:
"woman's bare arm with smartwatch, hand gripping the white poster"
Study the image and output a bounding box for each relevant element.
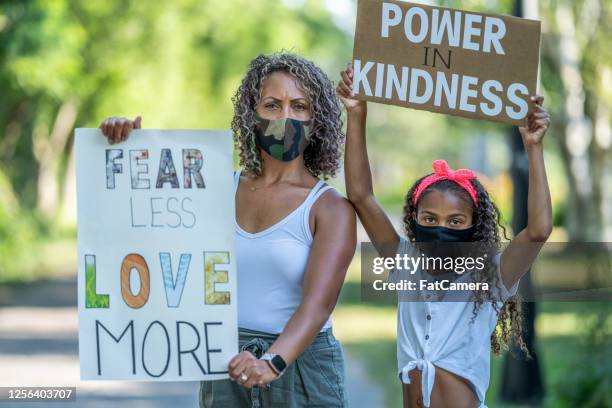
[229,192,357,387]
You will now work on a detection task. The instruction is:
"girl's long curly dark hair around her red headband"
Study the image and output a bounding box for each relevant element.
[403,175,531,358]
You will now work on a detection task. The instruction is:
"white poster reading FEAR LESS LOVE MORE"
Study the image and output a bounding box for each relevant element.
[75,129,238,381]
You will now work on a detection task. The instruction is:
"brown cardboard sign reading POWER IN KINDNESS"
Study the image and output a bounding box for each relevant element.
[353,0,540,125]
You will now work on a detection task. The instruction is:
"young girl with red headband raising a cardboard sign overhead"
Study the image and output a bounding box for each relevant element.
[336,65,552,408]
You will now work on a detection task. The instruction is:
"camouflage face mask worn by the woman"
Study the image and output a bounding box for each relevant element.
[255,114,312,161]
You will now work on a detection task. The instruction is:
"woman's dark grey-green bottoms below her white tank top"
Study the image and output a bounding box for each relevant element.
[199,327,348,408]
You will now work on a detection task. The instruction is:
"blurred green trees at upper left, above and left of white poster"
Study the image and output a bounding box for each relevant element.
[0,0,351,228]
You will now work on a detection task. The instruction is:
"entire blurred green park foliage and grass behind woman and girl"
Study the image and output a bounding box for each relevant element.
[0,0,612,407]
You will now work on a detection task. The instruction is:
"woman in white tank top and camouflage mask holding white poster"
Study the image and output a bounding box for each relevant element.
[100,53,356,408]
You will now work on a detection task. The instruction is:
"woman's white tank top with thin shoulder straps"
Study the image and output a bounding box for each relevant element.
[234,170,332,334]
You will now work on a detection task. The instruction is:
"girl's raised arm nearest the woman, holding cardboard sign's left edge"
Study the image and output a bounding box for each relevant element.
[336,65,399,256]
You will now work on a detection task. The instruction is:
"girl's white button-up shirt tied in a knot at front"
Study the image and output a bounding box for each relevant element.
[388,237,519,408]
